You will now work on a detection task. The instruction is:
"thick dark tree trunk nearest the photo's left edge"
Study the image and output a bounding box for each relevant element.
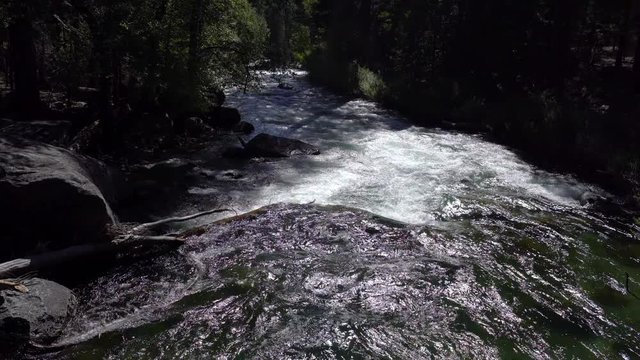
[8,2,40,116]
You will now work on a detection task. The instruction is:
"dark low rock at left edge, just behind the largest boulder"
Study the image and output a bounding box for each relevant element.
[0,121,72,146]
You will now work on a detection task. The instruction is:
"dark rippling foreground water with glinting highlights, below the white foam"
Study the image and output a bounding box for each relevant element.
[37,205,640,359]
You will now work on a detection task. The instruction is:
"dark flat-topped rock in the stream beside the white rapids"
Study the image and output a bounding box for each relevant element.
[244,133,320,157]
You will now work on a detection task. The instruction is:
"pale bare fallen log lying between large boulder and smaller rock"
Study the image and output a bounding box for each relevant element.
[0,235,184,279]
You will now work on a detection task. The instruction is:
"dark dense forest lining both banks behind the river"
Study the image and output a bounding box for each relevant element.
[0,0,640,202]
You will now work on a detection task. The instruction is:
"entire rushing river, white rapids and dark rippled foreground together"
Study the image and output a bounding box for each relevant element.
[32,74,640,359]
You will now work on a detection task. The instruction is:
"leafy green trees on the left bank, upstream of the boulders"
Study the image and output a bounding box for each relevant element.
[0,0,269,113]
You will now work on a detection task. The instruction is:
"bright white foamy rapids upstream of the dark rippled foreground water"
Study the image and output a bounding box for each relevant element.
[229,72,601,224]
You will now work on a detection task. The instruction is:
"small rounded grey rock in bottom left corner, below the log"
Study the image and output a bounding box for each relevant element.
[0,278,77,344]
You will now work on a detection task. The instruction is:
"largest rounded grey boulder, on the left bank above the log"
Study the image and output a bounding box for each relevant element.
[0,137,121,260]
